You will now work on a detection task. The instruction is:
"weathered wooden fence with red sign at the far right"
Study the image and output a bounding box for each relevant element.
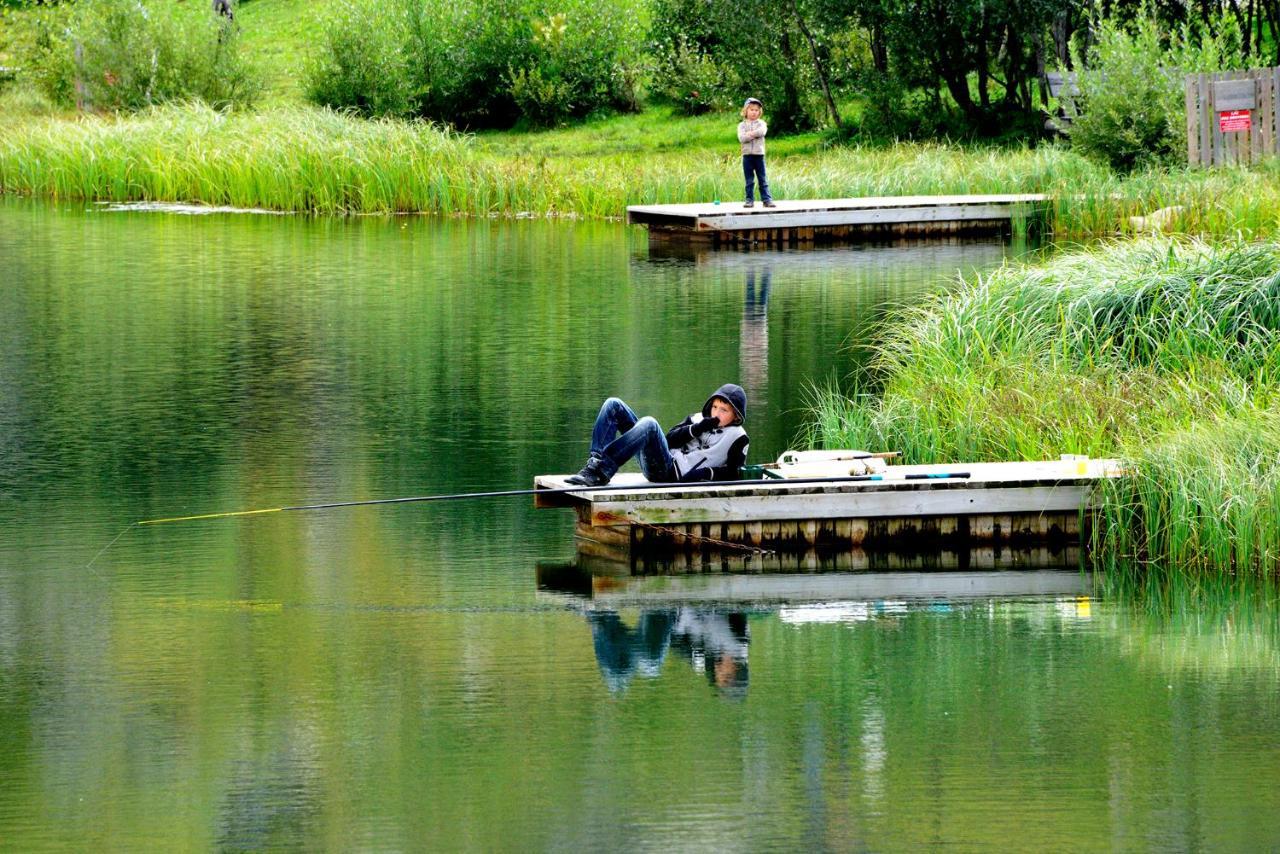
[1187,68,1280,166]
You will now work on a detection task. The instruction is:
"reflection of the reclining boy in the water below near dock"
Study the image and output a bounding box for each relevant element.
[586,608,750,699]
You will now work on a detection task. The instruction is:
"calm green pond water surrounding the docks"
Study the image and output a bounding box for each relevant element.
[0,201,1280,851]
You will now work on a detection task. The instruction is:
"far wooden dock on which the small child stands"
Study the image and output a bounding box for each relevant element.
[627,193,1048,246]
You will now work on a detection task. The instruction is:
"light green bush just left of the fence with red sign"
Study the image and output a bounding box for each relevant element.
[1071,14,1256,172]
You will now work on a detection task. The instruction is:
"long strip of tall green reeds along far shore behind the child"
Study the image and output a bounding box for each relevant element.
[0,104,1280,239]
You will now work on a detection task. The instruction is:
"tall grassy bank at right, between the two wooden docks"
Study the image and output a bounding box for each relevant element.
[813,239,1280,585]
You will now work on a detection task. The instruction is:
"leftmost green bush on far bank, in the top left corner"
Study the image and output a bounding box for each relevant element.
[20,0,261,110]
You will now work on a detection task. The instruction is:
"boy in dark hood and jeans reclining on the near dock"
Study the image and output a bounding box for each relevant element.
[566,383,749,487]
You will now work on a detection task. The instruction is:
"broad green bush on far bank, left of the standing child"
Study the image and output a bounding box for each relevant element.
[307,0,646,127]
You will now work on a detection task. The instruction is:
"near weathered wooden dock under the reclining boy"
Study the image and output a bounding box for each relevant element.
[536,460,1123,558]
